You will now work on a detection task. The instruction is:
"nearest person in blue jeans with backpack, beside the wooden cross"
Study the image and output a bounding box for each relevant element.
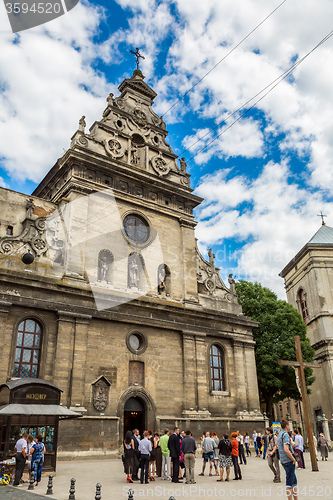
[278,420,298,500]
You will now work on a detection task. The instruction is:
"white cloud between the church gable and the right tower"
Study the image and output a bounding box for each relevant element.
[196,162,333,298]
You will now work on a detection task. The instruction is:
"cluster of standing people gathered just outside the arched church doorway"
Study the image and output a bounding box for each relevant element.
[122,427,260,484]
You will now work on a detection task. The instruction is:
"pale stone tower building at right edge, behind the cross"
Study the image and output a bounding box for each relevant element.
[280,222,333,439]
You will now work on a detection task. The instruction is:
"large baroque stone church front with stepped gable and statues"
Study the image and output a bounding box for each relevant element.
[0,70,265,457]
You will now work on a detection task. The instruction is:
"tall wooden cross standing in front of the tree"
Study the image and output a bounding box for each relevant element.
[279,335,321,471]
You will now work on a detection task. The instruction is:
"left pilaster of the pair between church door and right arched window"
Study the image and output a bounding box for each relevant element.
[183,332,197,410]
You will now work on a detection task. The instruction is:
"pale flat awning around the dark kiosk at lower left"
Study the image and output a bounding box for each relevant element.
[0,403,83,419]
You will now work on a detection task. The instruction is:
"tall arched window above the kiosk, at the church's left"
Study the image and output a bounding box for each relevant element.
[13,319,42,378]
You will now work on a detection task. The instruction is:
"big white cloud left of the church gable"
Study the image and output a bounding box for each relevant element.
[0,3,108,182]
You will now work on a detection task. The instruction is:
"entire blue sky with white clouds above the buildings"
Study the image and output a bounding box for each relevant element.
[0,0,333,297]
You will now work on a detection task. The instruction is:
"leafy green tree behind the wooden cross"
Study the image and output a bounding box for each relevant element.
[236,280,315,418]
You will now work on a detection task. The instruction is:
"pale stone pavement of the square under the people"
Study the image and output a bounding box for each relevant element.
[0,453,333,500]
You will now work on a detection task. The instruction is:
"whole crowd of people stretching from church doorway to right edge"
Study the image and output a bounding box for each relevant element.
[123,420,328,500]
